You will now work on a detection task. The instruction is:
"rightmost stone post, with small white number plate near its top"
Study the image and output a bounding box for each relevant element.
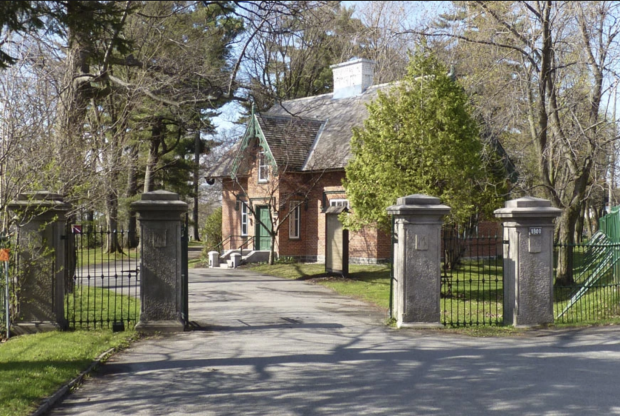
[495,197,562,327]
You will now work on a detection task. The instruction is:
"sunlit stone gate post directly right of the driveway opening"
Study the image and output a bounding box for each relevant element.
[387,195,450,328]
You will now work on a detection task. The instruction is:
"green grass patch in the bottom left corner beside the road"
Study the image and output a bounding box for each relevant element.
[0,330,135,416]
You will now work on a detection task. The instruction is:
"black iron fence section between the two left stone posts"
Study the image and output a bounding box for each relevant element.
[65,225,141,331]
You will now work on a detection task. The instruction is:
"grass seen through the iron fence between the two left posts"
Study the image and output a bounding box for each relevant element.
[65,286,140,329]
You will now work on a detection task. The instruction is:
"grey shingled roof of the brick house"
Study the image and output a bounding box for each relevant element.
[207,84,390,178]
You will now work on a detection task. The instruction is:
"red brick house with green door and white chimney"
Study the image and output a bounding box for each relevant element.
[207,59,390,264]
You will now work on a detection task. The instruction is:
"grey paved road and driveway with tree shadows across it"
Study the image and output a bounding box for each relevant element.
[52,269,620,415]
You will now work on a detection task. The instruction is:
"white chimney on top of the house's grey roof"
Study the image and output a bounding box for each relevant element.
[330,58,375,100]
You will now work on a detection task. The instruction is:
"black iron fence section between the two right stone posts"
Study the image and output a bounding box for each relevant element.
[441,229,507,327]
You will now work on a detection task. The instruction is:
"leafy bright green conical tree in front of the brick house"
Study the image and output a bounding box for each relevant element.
[344,52,505,229]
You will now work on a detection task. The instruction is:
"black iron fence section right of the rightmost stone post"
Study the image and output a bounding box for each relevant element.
[553,243,620,323]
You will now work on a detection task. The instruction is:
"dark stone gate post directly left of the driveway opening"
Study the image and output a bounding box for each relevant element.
[131,191,187,332]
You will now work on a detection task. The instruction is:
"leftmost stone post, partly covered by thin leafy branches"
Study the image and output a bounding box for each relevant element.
[8,191,70,335]
